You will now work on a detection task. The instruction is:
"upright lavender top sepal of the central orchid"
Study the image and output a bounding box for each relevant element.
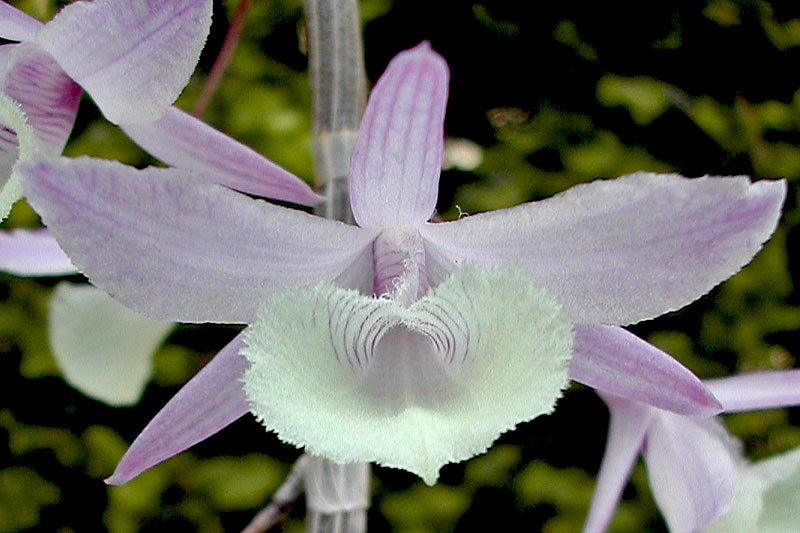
[350,42,449,227]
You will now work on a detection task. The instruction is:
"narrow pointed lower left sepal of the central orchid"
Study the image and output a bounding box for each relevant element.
[106,334,249,485]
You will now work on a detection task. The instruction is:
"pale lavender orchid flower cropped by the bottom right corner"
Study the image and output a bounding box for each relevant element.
[584,370,800,533]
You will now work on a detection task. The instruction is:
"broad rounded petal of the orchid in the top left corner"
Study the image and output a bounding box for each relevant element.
[36,0,212,123]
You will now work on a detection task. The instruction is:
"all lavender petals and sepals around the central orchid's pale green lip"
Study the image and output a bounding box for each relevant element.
[19,43,786,482]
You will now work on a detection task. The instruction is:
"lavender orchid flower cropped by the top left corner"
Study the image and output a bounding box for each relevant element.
[0,0,212,220]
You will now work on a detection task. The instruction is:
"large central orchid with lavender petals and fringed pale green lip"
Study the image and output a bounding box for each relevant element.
[17,43,785,484]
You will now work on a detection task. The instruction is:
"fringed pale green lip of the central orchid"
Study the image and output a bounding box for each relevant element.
[242,266,573,484]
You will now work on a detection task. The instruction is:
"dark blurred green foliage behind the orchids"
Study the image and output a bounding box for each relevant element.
[0,0,800,533]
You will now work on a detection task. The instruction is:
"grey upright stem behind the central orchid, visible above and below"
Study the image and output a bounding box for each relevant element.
[305,0,369,533]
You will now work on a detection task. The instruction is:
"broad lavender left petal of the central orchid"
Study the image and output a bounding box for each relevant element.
[17,157,374,323]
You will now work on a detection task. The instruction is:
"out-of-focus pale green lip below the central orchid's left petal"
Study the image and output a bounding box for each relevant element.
[47,282,175,405]
